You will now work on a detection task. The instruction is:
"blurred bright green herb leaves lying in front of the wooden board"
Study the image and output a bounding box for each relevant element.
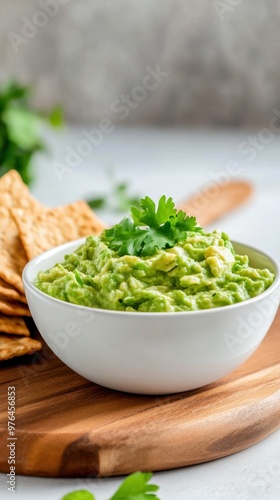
[61,472,160,500]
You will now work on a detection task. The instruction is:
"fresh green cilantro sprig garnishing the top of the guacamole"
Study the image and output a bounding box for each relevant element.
[103,196,201,257]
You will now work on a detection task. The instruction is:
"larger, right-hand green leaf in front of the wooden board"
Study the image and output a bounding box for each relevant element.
[110,472,159,500]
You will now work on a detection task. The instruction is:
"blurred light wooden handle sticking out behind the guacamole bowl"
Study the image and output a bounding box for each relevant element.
[178,180,253,227]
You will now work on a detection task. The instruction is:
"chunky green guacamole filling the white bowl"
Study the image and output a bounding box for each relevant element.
[35,231,274,312]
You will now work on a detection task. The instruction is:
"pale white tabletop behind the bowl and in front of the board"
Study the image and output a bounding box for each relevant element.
[0,129,280,500]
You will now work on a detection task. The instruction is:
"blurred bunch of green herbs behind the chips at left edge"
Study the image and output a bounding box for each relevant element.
[0,81,62,184]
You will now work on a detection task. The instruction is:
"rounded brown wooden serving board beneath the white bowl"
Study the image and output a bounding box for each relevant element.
[0,312,280,477]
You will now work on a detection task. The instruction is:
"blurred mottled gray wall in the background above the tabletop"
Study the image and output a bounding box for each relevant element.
[0,0,280,126]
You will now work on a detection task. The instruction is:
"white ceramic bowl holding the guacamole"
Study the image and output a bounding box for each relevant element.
[23,239,280,394]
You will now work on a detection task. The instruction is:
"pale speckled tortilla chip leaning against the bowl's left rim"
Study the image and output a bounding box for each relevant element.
[12,201,105,259]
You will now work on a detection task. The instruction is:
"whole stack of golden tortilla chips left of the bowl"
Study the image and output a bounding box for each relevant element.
[0,170,105,360]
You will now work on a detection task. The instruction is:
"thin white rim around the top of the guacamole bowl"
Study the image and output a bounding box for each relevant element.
[22,237,280,318]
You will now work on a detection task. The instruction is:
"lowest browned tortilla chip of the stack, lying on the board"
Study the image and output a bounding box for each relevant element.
[0,335,42,360]
